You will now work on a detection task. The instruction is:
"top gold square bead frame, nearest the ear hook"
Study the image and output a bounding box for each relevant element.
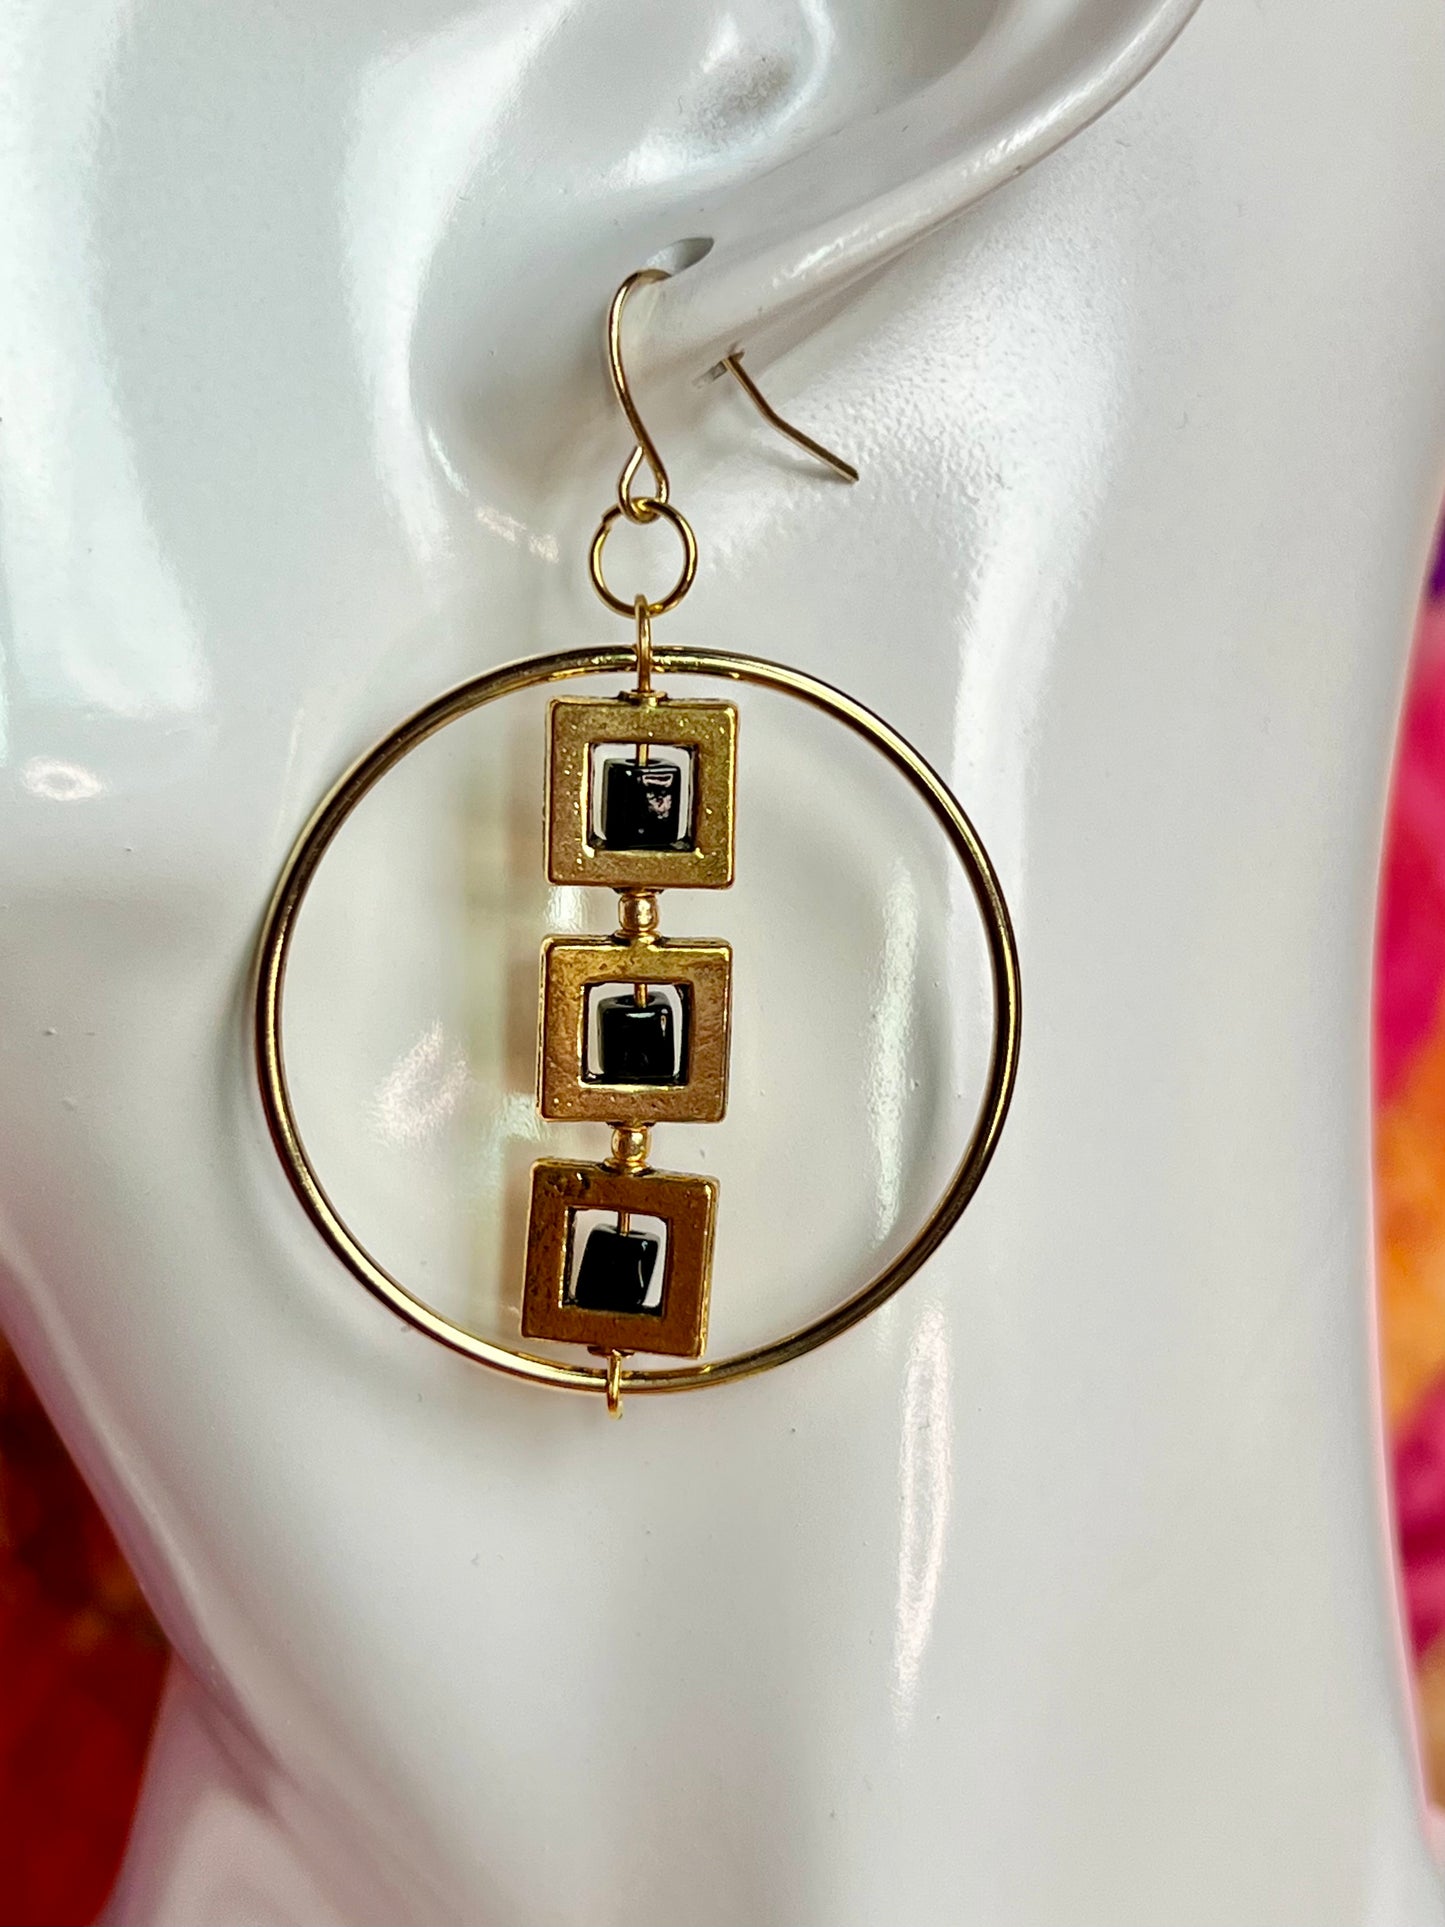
[547,696,738,890]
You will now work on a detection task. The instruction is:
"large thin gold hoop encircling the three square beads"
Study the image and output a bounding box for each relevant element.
[254,647,1021,1395]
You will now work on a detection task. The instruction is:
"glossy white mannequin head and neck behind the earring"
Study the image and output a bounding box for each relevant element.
[0,0,1445,1927]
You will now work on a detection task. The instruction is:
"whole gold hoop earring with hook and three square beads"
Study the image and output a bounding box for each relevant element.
[254,268,1019,1414]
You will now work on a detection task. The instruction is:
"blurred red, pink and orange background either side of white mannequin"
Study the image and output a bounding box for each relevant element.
[0,547,1445,1927]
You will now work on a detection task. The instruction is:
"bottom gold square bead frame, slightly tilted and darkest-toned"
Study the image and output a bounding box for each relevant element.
[522,1158,717,1359]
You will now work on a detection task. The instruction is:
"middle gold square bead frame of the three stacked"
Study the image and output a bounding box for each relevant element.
[538,937,732,1125]
